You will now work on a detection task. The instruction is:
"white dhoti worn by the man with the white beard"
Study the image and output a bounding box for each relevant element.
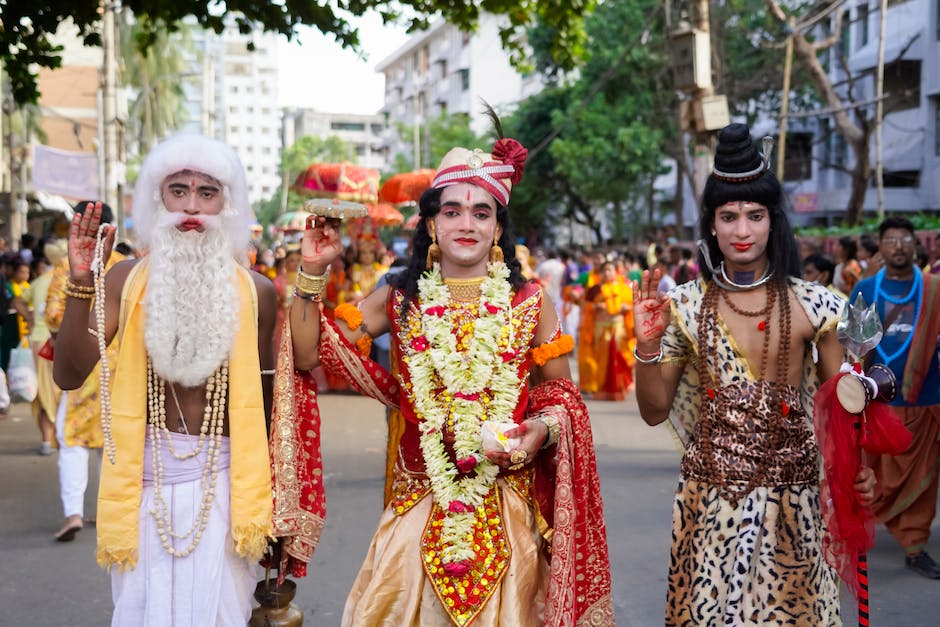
[111,434,260,627]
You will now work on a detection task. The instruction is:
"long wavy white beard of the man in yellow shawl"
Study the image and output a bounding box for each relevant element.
[144,220,238,387]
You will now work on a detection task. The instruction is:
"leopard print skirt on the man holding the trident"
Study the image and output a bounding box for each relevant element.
[665,478,842,627]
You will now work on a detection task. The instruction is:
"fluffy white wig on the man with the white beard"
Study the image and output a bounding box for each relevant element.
[133,133,255,254]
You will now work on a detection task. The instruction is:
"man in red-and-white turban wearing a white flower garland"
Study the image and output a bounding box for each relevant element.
[290,129,614,627]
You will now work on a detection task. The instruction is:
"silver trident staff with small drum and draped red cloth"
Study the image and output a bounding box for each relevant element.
[813,295,911,627]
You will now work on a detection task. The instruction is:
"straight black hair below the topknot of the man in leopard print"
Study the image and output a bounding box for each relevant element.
[698,170,803,283]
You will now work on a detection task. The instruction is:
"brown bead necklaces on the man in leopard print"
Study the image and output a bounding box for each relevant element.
[696,281,790,507]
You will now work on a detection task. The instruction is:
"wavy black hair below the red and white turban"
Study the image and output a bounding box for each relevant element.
[388,188,526,316]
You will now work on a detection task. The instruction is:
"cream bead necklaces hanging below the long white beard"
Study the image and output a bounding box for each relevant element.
[147,359,228,557]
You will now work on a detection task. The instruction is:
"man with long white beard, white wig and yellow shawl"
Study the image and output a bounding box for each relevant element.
[55,135,277,626]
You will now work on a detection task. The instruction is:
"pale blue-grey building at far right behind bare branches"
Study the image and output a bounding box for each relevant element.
[780,0,940,224]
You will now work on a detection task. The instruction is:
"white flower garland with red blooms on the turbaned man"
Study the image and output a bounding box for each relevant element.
[404,263,522,564]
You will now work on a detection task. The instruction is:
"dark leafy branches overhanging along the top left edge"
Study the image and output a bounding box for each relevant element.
[0,0,596,102]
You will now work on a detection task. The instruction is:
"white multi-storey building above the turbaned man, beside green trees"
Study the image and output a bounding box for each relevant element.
[376,13,542,167]
